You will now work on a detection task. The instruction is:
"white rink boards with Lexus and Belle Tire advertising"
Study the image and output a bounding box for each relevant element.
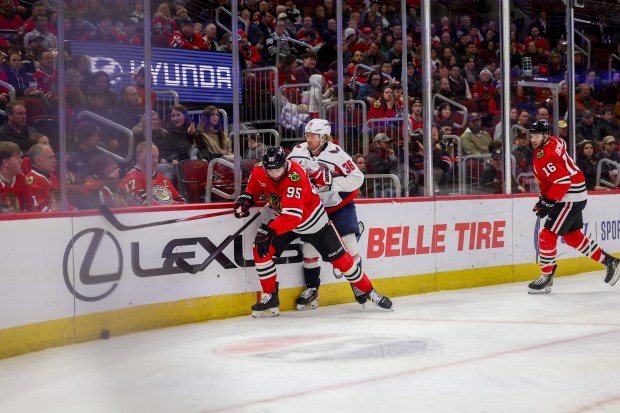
[0,194,620,329]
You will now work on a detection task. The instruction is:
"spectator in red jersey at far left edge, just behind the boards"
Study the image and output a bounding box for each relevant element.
[0,142,32,213]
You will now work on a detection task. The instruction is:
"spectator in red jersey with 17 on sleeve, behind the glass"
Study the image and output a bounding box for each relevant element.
[118,142,186,205]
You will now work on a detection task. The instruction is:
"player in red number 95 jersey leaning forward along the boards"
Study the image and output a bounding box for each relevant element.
[234,146,392,317]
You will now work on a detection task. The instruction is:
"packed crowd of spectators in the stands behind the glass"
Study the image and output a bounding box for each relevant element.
[0,0,620,212]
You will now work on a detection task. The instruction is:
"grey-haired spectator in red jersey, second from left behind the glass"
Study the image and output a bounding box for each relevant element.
[26,143,60,212]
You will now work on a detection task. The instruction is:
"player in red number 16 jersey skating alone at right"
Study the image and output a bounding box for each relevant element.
[529,120,620,294]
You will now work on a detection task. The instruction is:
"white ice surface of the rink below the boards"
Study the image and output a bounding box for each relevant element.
[0,271,620,413]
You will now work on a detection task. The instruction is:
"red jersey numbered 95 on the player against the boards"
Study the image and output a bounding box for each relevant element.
[246,161,328,235]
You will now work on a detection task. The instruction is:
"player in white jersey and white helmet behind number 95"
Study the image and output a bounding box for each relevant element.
[288,118,366,310]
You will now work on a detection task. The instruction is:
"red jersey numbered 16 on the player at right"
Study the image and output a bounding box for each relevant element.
[532,136,587,202]
